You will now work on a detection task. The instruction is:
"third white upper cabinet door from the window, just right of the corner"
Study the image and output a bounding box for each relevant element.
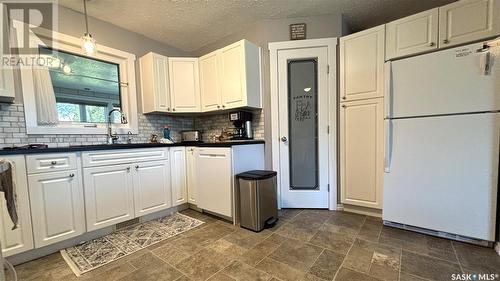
[199,52,222,112]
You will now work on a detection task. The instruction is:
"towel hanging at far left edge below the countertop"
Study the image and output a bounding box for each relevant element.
[0,160,19,230]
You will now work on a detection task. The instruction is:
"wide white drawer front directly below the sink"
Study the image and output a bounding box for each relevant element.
[82,148,168,167]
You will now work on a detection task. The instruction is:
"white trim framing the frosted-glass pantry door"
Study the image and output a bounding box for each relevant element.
[268,38,338,210]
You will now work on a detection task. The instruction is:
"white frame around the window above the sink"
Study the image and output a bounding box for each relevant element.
[13,23,138,135]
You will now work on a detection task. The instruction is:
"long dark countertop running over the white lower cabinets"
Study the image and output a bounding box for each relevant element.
[0,140,264,155]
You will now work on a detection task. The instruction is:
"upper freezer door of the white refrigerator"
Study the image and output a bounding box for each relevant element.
[385,43,500,117]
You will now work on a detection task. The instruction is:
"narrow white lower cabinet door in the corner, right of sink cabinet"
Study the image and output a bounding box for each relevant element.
[170,147,187,206]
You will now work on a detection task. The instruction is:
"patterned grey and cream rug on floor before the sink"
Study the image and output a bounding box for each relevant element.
[61,213,203,276]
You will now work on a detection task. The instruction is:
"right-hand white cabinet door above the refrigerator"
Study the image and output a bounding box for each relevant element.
[439,0,500,47]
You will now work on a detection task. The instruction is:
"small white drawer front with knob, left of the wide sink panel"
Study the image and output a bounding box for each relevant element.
[26,153,77,174]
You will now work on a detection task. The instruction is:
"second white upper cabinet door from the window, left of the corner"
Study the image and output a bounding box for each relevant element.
[168,58,201,112]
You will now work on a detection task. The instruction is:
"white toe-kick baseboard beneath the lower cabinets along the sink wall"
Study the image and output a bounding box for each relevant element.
[5,204,189,265]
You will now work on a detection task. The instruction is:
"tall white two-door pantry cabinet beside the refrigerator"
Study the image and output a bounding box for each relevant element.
[340,25,385,209]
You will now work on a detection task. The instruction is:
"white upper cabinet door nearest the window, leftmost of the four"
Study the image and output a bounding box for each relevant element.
[139,53,171,113]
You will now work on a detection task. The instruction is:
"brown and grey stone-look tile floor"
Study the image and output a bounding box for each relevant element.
[4,210,500,281]
